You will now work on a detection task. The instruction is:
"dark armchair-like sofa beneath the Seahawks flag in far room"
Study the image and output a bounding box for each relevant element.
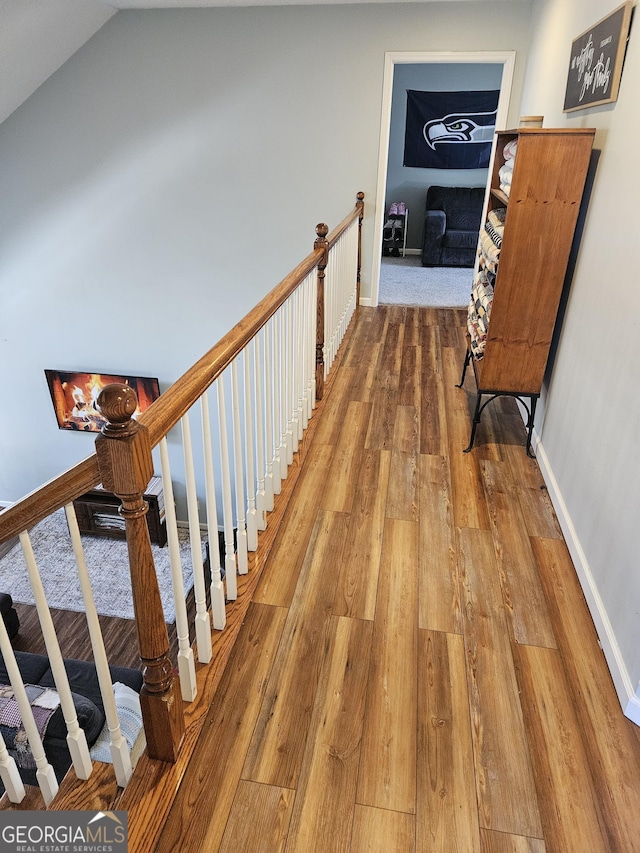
[422,186,485,267]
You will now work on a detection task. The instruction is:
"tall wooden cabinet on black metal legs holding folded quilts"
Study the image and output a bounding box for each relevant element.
[460,128,595,454]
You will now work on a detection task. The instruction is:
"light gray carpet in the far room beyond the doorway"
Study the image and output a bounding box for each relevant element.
[378,255,473,308]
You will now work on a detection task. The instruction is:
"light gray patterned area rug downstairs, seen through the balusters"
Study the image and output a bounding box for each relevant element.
[0,509,199,624]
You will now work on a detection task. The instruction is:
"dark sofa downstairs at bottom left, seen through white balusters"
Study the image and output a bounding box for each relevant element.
[0,651,142,790]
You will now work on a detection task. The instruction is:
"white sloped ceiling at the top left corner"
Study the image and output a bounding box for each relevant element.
[0,0,500,122]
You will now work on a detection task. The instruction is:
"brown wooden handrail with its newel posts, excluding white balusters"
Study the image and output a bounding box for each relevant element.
[0,188,364,800]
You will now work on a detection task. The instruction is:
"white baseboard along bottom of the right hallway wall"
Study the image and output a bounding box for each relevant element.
[533,430,640,726]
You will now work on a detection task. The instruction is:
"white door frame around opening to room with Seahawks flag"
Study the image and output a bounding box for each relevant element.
[361,50,516,306]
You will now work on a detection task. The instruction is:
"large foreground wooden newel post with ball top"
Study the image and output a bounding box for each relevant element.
[96,384,184,762]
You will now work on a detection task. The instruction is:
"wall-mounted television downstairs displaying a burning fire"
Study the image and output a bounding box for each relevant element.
[44,369,160,433]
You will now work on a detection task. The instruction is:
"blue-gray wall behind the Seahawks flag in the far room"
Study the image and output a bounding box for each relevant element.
[386,62,502,249]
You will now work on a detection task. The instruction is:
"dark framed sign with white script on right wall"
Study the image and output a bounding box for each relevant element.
[563,0,633,113]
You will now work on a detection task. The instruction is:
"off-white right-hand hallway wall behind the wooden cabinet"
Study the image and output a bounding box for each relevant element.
[522,0,640,723]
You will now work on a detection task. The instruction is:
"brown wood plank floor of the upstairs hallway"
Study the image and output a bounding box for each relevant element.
[155,307,640,853]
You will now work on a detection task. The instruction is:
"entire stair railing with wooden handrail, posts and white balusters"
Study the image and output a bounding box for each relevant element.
[0,193,364,804]
